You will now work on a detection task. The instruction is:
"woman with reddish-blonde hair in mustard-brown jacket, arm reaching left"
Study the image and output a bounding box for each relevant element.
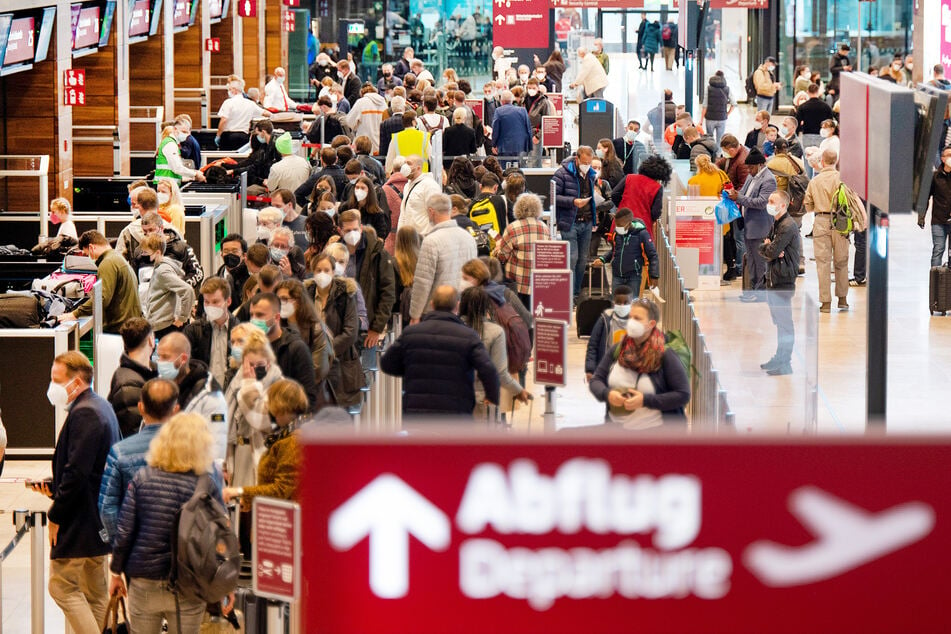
[223,379,310,510]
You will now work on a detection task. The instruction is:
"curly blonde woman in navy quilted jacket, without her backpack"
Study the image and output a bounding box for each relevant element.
[109,413,234,634]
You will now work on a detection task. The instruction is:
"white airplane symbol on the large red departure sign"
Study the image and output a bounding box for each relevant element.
[743,487,935,587]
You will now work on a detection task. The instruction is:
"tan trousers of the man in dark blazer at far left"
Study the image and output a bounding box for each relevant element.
[48,555,109,634]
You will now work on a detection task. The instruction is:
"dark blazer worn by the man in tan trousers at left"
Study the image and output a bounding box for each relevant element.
[48,388,119,559]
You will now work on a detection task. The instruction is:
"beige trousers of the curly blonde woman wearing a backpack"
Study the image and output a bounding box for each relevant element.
[129,577,205,634]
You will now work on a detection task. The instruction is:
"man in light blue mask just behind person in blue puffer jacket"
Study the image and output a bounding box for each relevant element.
[156,332,228,462]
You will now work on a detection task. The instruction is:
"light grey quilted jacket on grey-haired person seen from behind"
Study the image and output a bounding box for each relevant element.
[410,219,478,319]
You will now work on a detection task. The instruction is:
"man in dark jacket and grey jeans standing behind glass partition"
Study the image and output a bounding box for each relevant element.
[759,190,802,376]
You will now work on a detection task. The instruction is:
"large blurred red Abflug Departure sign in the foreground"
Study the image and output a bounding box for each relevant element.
[301,436,951,633]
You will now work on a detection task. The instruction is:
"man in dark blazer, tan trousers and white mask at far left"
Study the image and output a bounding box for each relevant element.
[38,350,119,633]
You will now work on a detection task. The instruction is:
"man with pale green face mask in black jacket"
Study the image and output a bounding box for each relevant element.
[251,293,317,409]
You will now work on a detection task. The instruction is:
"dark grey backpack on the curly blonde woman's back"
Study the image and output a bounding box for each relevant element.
[168,473,241,603]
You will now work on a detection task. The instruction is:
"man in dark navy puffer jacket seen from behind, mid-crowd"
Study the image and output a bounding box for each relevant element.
[380,286,499,418]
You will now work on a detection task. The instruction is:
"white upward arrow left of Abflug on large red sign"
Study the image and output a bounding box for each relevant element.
[329,473,450,599]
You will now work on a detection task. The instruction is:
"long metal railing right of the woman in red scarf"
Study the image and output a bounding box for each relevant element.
[655,222,735,432]
